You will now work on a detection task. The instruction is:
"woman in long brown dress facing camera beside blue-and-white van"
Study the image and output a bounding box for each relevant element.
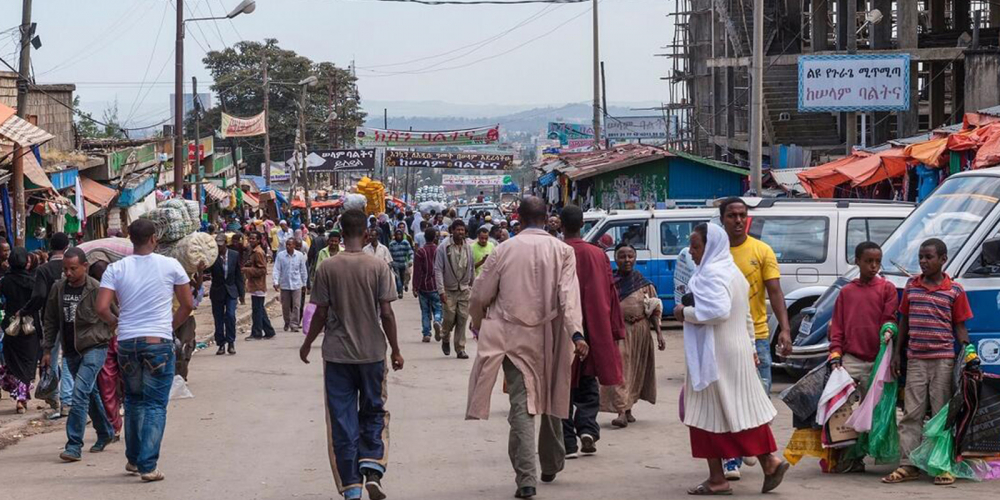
[601,243,666,427]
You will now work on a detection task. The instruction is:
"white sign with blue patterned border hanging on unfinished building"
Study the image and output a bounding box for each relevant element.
[799,54,910,113]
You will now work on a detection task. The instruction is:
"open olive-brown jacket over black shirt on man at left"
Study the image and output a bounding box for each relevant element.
[42,276,118,353]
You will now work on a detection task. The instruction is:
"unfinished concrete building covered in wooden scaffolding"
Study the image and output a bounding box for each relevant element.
[662,0,1000,167]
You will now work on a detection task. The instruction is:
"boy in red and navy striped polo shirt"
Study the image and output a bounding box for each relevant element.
[882,238,972,485]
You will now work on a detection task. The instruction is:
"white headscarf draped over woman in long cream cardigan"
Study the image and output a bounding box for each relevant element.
[684,224,740,391]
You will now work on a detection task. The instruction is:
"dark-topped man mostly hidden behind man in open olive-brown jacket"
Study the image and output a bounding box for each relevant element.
[27,233,73,418]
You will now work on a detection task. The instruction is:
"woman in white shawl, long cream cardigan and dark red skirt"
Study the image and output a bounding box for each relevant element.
[674,224,789,495]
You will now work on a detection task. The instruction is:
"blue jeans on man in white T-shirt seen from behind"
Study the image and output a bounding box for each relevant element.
[118,338,175,474]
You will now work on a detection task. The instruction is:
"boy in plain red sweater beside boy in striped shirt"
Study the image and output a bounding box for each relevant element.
[829,241,899,472]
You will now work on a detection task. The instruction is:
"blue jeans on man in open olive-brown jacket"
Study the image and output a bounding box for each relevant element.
[63,346,115,457]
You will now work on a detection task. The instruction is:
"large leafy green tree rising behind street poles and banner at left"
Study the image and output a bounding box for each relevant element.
[193,39,365,174]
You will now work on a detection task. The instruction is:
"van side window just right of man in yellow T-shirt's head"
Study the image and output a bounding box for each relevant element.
[750,215,830,264]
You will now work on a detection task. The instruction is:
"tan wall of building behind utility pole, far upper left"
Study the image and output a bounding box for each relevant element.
[0,71,76,151]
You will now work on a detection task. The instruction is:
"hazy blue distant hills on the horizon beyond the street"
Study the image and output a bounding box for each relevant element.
[362,101,660,134]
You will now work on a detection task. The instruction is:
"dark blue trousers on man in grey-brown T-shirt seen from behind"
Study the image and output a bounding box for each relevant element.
[323,361,389,499]
